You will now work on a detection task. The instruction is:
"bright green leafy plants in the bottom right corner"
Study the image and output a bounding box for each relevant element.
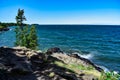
[100,72,120,80]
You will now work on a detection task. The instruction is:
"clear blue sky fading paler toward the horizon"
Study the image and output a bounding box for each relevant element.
[0,0,120,25]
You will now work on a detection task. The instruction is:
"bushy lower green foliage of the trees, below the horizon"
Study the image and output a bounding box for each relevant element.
[15,26,38,50]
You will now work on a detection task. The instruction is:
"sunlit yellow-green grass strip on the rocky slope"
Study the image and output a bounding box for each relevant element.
[54,61,101,78]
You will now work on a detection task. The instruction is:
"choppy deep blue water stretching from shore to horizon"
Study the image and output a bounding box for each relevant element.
[0,25,120,71]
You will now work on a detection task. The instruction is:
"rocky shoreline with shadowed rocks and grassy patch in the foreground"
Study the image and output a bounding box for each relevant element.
[0,47,103,80]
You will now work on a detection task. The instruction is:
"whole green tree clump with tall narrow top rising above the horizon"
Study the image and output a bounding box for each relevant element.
[15,9,38,50]
